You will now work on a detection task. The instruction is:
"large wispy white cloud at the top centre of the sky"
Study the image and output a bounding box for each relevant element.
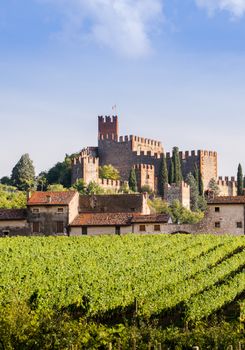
[38,0,163,57]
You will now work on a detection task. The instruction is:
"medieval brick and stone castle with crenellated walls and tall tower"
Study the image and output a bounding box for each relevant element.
[72,116,236,197]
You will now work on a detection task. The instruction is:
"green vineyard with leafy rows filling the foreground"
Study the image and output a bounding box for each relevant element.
[0,235,245,349]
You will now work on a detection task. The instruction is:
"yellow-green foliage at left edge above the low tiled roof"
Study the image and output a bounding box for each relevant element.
[0,185,26,209]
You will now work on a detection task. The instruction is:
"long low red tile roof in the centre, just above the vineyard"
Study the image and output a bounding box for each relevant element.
[71,213,135,226]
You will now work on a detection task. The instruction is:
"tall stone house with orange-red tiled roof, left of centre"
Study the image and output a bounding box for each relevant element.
[27,191,79,235]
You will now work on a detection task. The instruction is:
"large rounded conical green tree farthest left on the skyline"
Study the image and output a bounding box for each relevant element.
[11,153,35,190]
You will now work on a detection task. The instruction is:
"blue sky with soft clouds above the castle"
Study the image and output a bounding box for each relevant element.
[0,0,245,178]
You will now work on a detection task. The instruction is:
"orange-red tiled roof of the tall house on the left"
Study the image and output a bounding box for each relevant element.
[27,191,77,205]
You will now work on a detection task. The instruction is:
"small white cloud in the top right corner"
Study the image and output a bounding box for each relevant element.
[196,0,245,17]
